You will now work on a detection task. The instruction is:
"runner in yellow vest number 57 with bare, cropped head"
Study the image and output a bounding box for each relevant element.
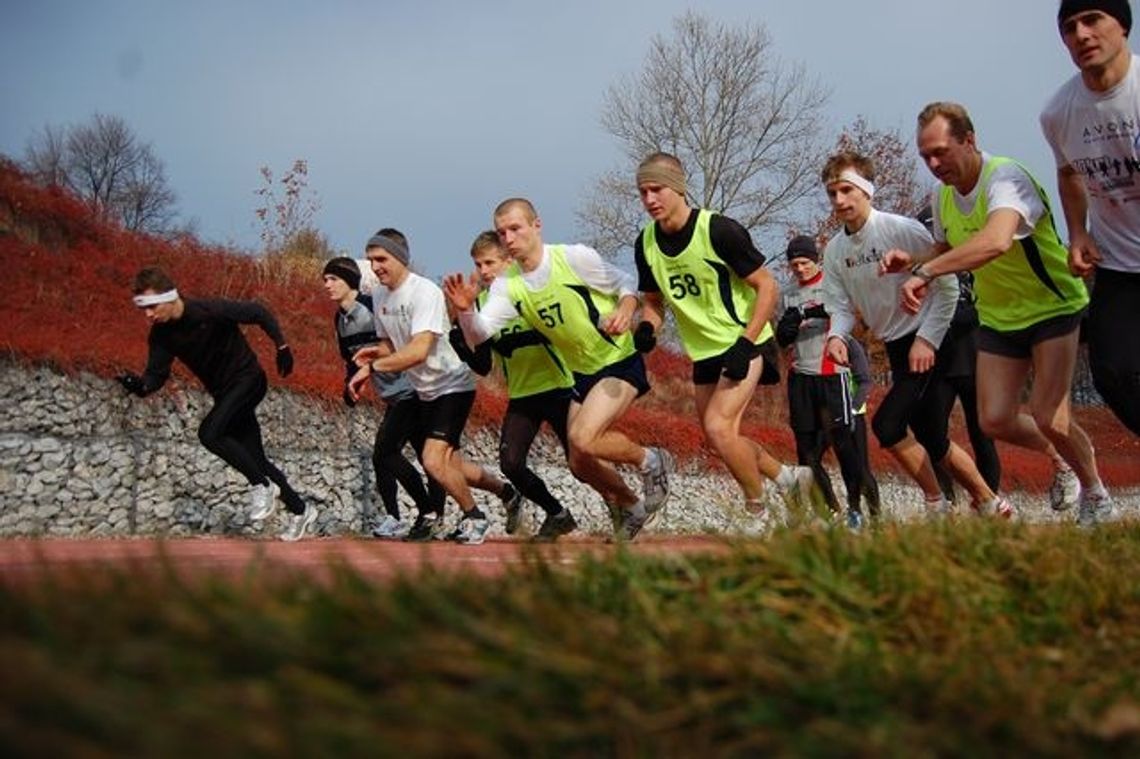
[445,198,674,540]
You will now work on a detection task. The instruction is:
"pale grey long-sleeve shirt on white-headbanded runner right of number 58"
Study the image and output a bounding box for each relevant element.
[823,209,958,348]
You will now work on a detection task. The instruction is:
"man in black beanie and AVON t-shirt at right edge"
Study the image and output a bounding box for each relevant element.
[1041,0,1140,435]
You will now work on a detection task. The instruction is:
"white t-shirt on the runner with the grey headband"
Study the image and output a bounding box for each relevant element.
[372,271,475,400]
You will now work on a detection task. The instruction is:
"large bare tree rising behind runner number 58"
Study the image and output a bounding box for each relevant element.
[577,11,829,254]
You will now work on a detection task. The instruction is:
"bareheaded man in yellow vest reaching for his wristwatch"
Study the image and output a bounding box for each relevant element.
[884,103,1114,527]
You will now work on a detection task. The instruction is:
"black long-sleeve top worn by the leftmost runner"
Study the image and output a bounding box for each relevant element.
[143,299,285,398]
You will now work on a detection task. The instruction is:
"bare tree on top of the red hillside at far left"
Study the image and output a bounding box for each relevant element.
[25,113,177,234]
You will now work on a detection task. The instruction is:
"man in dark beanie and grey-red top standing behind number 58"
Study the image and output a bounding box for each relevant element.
[776,235,877,530]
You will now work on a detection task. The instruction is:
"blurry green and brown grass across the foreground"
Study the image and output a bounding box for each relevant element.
[0,522,1140,757]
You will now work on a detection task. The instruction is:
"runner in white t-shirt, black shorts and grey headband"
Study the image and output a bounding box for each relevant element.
[349,228,520,546]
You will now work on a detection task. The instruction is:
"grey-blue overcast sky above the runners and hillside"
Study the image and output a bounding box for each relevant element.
[0,0,1075,275]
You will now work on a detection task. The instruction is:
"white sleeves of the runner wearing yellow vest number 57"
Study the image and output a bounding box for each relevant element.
[459,245,637,345]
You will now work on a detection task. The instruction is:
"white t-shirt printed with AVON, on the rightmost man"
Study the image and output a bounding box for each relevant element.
[1041,55,1140,272]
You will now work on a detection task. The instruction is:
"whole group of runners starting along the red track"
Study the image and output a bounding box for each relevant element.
[120,0,1140,545]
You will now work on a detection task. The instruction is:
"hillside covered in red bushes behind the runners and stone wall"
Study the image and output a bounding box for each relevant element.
[0,160,1140,487]
